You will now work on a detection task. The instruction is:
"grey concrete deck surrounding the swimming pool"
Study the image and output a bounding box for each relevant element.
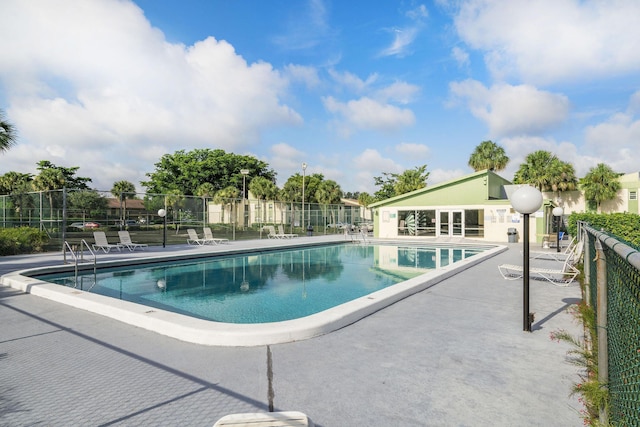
[0,236,582,427]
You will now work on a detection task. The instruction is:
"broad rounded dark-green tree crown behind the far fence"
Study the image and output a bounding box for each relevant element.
[142,149,276,195]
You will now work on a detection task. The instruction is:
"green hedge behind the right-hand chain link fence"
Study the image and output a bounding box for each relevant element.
[568,213,640,248]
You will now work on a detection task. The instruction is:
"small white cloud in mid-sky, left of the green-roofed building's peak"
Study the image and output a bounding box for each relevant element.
[322,96,415,136]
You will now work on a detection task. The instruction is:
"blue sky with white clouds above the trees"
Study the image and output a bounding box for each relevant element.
[0,0,640,193]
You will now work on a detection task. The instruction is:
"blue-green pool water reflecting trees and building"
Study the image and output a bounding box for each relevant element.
[38,244,484,324]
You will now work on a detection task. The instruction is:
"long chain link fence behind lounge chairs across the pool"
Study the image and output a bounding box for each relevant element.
[0,189,372,250]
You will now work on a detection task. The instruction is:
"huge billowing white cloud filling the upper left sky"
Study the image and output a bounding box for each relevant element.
[0,0,302,189]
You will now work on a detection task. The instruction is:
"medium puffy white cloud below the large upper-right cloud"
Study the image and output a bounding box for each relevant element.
[450,80,569,137]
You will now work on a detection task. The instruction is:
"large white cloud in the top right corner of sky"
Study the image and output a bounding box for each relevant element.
[455,0,640,84]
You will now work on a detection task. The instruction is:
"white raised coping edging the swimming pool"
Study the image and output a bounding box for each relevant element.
[0,240,508,347]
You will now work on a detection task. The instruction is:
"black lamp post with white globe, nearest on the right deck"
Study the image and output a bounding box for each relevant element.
[511,185,542,332]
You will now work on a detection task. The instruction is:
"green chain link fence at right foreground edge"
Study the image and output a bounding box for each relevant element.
[579,223,640,426]
